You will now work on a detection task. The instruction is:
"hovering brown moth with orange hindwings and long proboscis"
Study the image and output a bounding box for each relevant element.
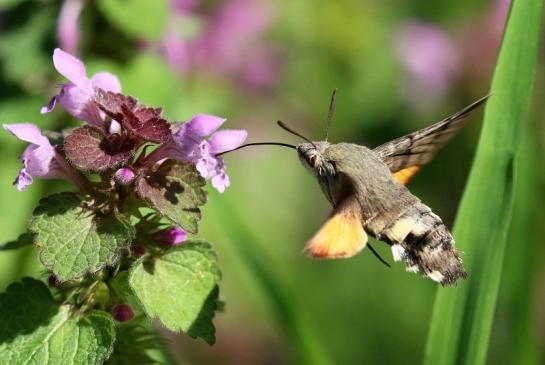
[223,92,487,285]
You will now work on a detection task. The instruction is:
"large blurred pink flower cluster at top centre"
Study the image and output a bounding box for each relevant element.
[163,0,279,87]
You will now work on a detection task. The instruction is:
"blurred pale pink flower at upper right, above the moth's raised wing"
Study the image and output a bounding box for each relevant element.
[395,22,459,108]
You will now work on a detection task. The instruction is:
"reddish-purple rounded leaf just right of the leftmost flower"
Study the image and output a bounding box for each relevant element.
[64,125,136,172]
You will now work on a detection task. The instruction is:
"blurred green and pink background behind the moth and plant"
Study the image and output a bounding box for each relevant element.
[0,0,545,364]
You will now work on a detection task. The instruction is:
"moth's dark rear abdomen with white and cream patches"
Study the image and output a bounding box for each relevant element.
[377,203,467,285]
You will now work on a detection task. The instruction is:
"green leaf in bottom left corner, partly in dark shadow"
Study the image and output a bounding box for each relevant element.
[0,278,115,365]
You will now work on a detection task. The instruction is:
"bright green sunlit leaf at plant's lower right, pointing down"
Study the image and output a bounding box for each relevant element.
[129,241,220,344]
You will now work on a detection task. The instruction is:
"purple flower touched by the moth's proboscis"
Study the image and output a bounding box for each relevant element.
[143,114,248,193]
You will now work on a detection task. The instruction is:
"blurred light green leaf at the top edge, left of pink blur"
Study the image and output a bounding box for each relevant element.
[98,0,168,40]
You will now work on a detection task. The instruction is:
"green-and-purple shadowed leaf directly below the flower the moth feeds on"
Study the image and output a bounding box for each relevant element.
[137,160,206,233]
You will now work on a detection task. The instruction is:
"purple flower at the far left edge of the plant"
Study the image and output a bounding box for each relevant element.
[4,123,67,191]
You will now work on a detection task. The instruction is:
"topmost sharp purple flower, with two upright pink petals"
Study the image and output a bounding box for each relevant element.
[41,48,121,129]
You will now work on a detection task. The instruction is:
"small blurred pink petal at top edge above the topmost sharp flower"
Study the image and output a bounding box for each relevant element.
[57,0,83,54]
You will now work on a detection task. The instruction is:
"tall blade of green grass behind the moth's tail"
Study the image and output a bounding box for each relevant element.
[425,0,542,365]
